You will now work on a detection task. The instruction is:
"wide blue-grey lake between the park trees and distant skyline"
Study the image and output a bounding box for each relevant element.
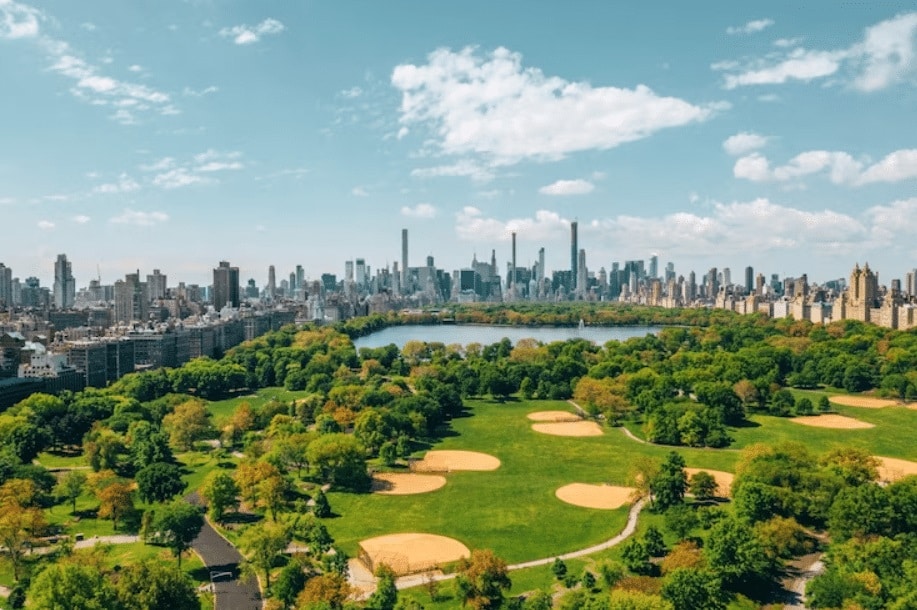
[353,324,662,349]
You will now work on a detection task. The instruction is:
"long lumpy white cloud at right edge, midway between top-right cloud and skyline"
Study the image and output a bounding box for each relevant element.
[733,149,917,186]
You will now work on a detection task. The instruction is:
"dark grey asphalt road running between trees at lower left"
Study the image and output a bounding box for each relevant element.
[186,492,262,610]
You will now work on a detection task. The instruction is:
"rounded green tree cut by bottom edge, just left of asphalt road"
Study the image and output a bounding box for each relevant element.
[115,559,201,610]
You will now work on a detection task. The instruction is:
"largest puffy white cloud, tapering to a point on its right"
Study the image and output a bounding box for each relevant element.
[391,48,717,169]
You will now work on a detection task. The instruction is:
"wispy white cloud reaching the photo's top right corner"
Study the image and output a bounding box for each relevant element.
[711,13,917,92]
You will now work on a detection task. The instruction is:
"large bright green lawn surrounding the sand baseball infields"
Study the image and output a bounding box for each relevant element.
[326,401,737,563]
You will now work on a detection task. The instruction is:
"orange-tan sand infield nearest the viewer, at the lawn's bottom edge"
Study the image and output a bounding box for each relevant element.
[360,533,471,575]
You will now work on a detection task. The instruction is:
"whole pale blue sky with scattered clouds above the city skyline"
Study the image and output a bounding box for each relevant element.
[0,0,917,286]
